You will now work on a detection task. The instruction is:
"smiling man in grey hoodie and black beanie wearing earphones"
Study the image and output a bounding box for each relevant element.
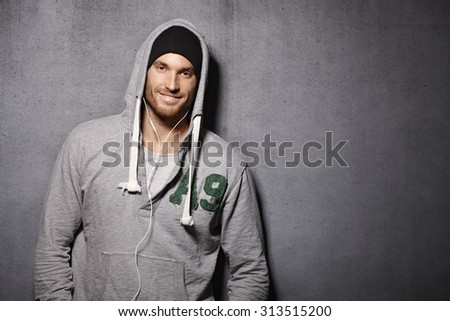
[35,19,268,300]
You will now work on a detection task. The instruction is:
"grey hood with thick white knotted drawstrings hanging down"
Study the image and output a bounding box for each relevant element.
[118,19,209,226]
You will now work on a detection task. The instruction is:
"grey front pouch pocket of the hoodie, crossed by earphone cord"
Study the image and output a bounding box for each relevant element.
[100,252,188,301]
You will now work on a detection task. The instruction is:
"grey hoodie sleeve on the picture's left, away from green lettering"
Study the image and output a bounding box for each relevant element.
[34,136,82,300]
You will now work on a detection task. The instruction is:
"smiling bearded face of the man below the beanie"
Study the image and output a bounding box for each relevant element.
[145,53,197,124]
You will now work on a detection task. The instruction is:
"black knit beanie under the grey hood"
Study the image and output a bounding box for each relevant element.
[147,26,202,79]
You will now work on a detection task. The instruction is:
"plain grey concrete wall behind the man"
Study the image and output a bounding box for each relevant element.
[0,0,450,300]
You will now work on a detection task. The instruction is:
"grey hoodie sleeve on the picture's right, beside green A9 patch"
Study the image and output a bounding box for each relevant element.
[221,168,269,300]
